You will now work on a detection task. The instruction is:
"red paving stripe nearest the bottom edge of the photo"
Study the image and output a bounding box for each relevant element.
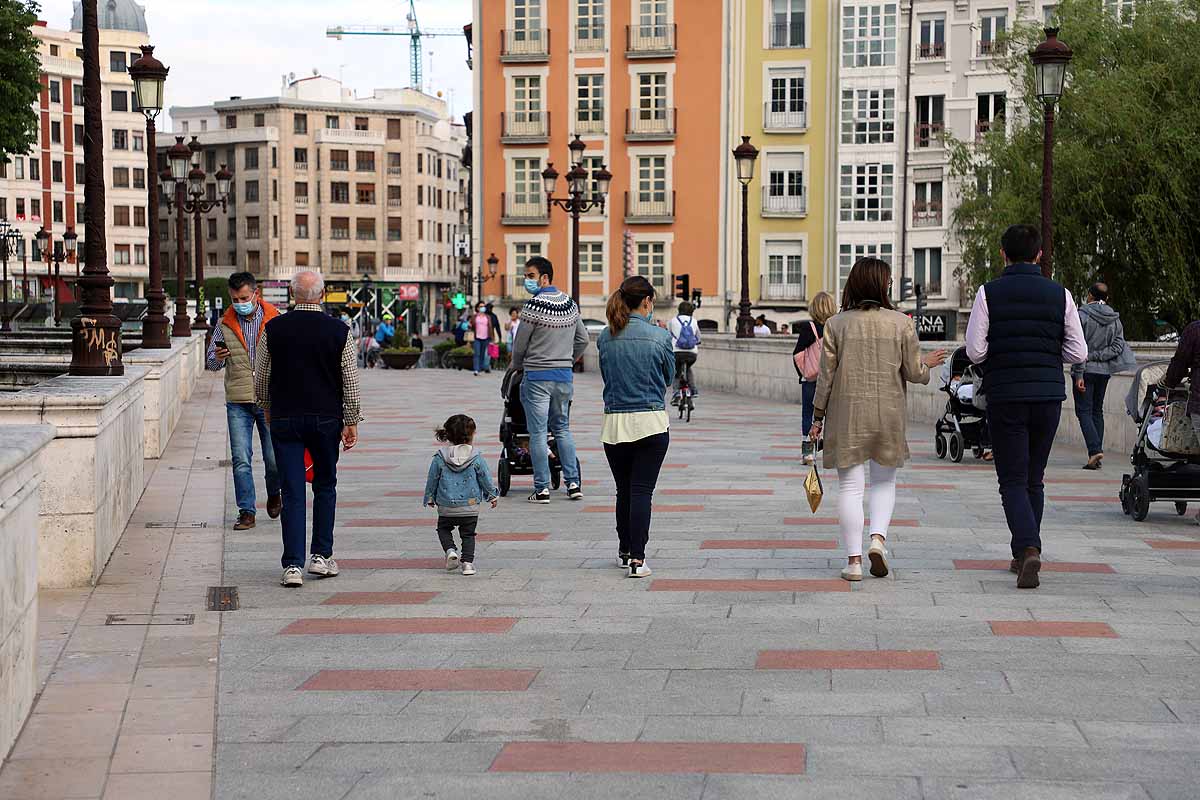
[490,741,805,775]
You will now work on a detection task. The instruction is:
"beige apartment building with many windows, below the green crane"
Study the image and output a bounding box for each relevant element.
[166,74,466,328]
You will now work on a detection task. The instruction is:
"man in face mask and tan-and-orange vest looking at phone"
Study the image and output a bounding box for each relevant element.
[206,272,283,530]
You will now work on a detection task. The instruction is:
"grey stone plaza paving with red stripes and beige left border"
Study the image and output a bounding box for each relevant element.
[0,371,1200,800]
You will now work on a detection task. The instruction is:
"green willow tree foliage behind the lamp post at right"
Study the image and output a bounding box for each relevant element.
[948,0,1200,338]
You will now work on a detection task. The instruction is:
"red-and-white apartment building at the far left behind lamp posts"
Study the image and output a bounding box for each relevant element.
[0,0,149,302]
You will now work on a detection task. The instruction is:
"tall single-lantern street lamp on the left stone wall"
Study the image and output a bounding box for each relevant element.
[130,44,170,350]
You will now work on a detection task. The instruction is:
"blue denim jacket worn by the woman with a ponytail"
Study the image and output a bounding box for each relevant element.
[596,314,674,414]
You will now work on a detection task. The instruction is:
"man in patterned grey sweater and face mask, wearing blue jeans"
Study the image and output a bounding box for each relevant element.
[512,255,588,505]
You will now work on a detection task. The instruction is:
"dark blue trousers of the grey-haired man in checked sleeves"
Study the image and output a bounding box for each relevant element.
[271,414,342,570]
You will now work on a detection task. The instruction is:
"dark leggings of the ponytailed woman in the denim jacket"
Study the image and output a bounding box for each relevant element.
[604,432,671,561]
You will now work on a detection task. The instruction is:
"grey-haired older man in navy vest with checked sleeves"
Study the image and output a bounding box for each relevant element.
[254,270,362,588]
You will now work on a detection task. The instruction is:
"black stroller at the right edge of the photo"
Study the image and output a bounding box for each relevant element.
[1120,361,1200,522]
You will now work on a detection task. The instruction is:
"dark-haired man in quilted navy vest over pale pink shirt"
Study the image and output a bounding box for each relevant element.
[967,225,1087,589]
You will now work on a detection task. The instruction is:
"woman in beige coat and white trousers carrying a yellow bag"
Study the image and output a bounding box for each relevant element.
[810,258,946,581]
